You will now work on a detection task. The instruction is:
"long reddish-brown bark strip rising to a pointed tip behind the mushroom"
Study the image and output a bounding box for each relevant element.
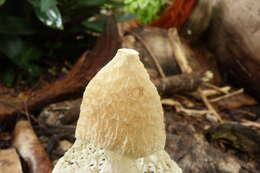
[0,18,121,122]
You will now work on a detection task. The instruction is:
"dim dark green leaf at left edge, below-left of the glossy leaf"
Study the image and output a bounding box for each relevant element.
[0,16,35,35]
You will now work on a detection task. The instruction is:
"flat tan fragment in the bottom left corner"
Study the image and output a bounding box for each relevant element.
[0,148,23,173]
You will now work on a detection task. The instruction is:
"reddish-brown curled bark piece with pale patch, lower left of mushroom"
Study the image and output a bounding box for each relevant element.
[13,120,53,173]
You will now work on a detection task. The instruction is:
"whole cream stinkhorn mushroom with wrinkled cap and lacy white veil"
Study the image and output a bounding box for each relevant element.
[53,49,182,173]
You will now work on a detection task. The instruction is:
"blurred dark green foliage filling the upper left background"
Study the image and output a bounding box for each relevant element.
[0,0,165,86]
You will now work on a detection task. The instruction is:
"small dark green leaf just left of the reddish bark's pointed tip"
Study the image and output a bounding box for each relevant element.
[82,15,107,32]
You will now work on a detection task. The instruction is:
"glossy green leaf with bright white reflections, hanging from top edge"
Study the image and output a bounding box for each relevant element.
[29,0,63,30]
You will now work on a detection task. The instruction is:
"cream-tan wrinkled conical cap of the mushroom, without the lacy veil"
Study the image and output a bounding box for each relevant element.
[76,49,166,158]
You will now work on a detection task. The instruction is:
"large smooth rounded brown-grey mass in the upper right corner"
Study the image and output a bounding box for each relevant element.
[208,0,260,98]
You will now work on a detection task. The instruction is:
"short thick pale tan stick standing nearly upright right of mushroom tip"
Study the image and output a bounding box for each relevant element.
[168,28,192,74]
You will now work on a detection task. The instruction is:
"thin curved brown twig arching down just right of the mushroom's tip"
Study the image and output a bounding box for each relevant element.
[129,31,166,78]
